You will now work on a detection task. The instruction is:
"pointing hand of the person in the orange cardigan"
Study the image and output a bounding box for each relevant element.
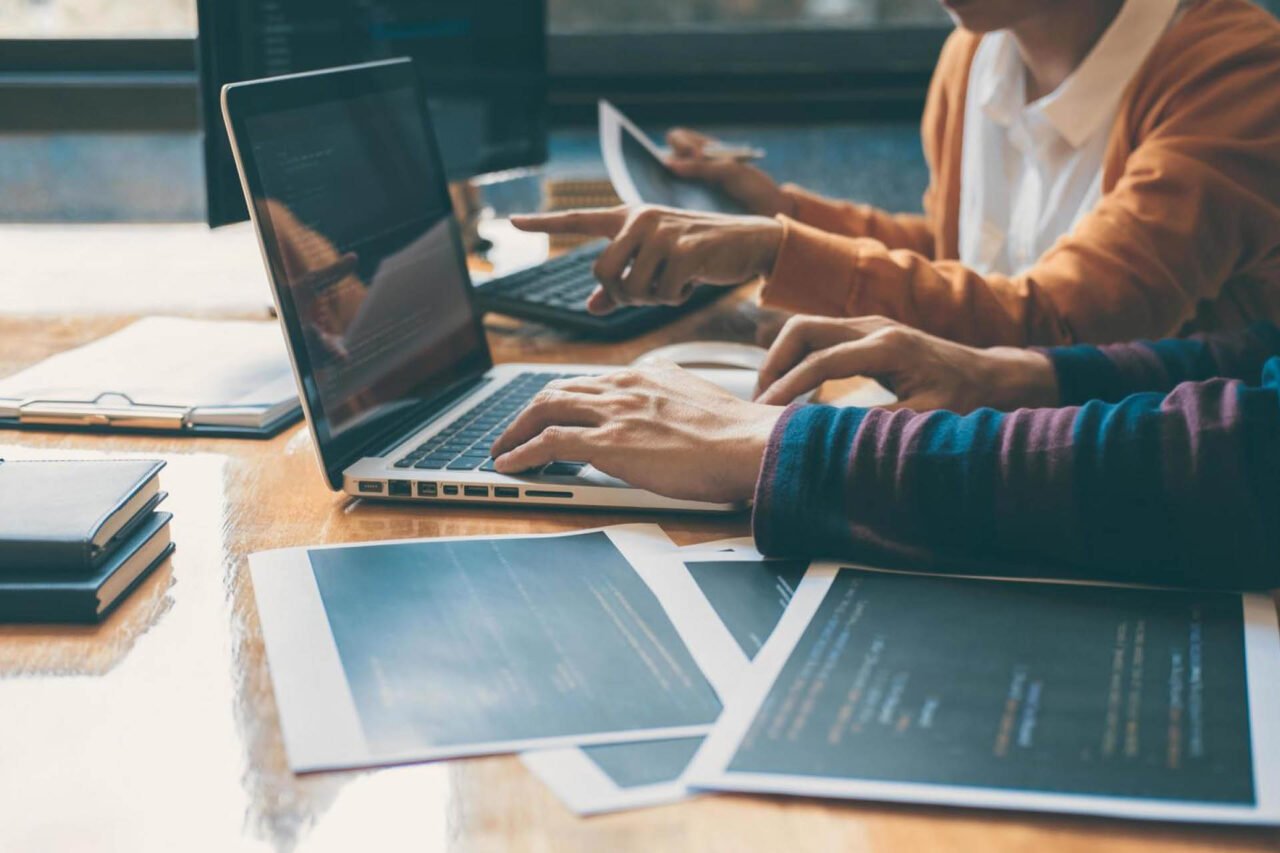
[511,205,782,314]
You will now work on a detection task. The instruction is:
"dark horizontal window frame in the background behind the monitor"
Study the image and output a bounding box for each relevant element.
[0,24,950,132]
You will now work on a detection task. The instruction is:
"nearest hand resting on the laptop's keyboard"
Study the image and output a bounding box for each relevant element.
[492,362,782,502]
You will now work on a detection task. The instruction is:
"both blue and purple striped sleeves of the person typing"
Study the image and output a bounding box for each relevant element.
[753,327,1280,589]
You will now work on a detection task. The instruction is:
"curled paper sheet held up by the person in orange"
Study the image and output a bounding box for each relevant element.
[599,100,749,214]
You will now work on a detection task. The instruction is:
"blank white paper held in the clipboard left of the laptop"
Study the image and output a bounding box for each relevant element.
[0,318,298,423]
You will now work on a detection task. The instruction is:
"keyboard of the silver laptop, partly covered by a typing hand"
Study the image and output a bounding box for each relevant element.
[396,373,582,474]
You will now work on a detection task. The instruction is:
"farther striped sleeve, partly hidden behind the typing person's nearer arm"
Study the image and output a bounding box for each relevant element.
[1044,324,1280,406]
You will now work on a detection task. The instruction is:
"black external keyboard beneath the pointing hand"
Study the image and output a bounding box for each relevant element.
[476,242,732,339]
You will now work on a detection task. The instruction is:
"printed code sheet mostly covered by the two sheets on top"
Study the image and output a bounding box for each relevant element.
[521,540,808,815]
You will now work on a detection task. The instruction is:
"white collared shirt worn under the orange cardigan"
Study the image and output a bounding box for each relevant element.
[960,0,1179,275]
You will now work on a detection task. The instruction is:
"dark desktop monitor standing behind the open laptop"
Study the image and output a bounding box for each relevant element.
[197,0,547,225]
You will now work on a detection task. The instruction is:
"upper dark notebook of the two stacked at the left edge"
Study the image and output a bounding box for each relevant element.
[0,460,164,578]
